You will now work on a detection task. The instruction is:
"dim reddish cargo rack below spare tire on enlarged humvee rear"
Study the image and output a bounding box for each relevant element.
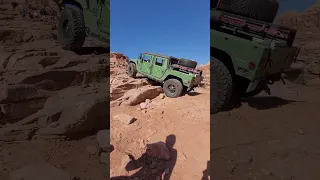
[210,10,297,46]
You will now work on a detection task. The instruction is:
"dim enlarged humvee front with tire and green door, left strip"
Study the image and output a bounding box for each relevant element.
[58,0,110,51]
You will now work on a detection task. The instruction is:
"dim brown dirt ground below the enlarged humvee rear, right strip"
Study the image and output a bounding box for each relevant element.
[211,81,320,180]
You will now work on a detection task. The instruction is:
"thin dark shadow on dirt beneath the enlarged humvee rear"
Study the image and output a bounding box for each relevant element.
[222,96,303,111]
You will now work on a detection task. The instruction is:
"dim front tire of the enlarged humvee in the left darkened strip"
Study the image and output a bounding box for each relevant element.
[58,4,86,51]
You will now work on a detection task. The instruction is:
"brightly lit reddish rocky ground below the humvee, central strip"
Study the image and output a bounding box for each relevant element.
[110,58,210,180]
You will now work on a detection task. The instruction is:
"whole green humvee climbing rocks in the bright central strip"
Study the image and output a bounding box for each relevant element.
[128,53,203,98]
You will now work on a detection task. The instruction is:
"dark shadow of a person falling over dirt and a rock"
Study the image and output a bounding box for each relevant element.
[111,134,177,180]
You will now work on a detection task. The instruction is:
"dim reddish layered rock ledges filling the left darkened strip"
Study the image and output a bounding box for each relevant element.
[0,0,112,180]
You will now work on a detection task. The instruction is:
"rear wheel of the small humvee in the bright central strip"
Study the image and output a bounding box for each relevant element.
[163,79,183,98]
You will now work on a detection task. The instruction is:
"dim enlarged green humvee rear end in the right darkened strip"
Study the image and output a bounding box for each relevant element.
[210,0,299,114]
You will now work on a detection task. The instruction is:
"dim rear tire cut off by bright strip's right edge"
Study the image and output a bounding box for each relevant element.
[210,57,233,114]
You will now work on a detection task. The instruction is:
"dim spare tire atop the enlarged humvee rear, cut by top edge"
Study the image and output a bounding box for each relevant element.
[217,0,279,23]
